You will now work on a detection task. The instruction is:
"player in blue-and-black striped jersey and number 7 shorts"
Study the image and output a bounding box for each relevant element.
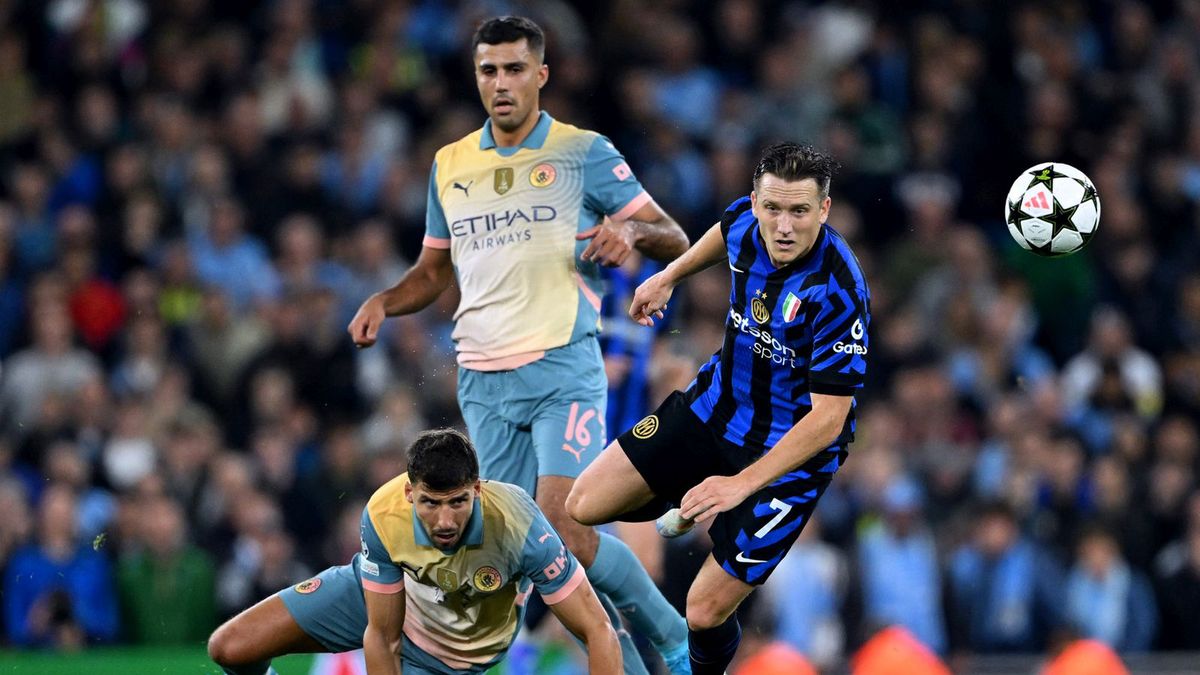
[566,143,870,675]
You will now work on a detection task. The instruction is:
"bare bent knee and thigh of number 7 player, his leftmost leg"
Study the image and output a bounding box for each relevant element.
[566,441,661,525]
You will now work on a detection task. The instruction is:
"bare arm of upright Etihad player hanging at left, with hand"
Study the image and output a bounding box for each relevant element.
[347,246,454,347]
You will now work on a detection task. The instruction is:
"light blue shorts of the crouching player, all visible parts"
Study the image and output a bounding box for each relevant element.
[280,556,503,675]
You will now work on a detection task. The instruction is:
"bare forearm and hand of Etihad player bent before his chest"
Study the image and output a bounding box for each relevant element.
[575,199,688,267]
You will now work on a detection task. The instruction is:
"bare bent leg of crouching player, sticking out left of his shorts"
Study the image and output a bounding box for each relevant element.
[209,593,328,665]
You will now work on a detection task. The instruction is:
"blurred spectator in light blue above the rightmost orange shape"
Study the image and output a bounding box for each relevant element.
[1066,528,1158,652]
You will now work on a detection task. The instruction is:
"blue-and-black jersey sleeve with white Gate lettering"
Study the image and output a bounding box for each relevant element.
[809,286,871,396]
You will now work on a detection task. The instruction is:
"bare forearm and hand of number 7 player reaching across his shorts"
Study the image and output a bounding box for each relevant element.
[679,394,854,521]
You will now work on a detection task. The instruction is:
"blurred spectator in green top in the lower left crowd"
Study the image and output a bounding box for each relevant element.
[116,498,216,645]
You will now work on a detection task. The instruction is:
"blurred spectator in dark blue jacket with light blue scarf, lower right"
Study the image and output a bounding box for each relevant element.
[948,502,1064,652]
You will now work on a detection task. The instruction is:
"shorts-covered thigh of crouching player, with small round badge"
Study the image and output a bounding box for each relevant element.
[278,565,367,652]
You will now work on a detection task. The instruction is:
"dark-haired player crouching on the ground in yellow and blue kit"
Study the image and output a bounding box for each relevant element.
[209,429,622,675]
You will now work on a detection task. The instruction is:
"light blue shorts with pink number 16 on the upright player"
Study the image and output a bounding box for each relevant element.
[458,338,608,495]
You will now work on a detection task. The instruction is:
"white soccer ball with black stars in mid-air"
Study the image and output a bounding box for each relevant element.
[1004,162,1100,257]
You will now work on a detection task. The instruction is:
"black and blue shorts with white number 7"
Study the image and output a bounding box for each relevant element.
[618,392,846,585]
